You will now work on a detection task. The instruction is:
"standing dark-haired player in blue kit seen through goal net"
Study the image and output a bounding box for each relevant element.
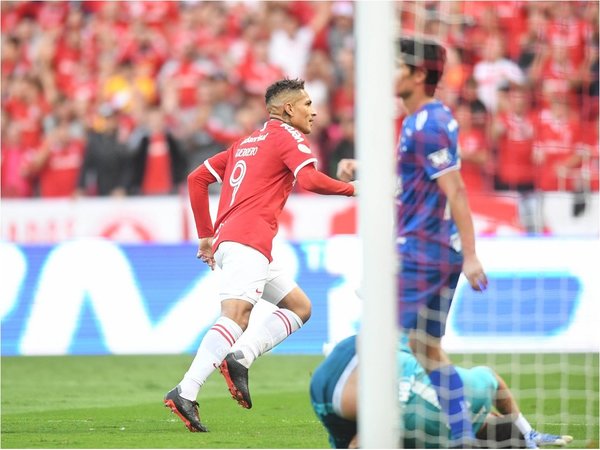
[395,39,487,447]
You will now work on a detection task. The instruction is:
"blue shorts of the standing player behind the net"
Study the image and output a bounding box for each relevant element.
[397,250,462,337]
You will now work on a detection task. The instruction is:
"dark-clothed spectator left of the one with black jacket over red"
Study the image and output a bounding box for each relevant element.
[76,104,129,196]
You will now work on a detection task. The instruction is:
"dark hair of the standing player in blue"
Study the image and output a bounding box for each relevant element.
[398,38,446,96]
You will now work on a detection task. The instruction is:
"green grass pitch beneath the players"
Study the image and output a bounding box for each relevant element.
[0,355,598,448]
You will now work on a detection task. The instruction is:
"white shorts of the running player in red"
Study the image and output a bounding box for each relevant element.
[214,241,297,305]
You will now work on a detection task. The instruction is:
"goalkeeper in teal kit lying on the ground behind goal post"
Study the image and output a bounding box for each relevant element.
[310,336,573,448]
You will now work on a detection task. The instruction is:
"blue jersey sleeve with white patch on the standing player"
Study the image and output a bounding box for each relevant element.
[415,119,460,180]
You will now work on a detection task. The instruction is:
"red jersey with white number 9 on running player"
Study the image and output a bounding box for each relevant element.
[198,119,317,261]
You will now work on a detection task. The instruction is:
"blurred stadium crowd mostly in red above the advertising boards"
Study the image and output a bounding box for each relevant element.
[1,1,598,198]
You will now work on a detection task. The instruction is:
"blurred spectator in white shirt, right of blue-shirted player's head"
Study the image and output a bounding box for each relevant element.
[473,35,526,113]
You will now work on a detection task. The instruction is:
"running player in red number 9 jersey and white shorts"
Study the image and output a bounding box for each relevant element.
[164,79,355,432]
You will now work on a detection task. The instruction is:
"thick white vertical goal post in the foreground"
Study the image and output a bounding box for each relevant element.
[355,1,400,448]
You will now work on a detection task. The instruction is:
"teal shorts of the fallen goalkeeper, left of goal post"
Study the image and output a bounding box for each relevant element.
[310,336,357,448]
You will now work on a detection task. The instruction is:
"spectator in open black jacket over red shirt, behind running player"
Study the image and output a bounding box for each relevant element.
[128,107,187,195]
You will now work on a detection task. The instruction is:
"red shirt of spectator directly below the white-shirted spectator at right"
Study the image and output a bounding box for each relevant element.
[496,113,535,186]
